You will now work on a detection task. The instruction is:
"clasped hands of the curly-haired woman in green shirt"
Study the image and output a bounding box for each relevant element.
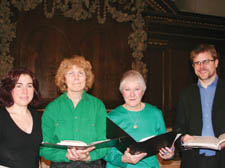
[66,147,95,161]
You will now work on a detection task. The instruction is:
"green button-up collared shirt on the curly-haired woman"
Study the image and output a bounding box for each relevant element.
[40,91,107,162]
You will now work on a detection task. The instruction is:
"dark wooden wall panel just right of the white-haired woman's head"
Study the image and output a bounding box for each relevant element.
[143,45,170,125]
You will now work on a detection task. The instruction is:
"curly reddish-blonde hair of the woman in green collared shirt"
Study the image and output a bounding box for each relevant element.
[55,55,94,92]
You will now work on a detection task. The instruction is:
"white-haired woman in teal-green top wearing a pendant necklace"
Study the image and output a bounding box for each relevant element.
[105,70,174,168]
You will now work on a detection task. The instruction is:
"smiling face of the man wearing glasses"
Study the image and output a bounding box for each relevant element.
[193,52,219,84]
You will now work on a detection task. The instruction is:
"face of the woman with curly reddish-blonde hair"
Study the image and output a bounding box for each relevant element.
[65,65,86,93]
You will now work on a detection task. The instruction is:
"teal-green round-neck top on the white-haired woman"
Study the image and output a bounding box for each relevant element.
[105,103,166,168]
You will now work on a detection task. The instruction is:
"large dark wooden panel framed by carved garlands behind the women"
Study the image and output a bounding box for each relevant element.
[14,5,132,109]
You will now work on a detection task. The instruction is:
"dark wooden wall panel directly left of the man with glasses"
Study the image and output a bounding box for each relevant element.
[170,46,196,125]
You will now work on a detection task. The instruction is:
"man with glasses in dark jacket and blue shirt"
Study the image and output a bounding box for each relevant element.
[174,44,225,168]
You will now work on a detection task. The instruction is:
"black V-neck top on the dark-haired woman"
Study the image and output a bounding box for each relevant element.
[0,107,42,168]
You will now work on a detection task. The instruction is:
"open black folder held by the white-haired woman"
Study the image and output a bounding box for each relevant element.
[107,118,177,156]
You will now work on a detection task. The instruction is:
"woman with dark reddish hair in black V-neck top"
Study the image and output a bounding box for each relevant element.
[0,68,42,168]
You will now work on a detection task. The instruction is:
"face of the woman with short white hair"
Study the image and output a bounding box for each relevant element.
[122,78,144,109]
